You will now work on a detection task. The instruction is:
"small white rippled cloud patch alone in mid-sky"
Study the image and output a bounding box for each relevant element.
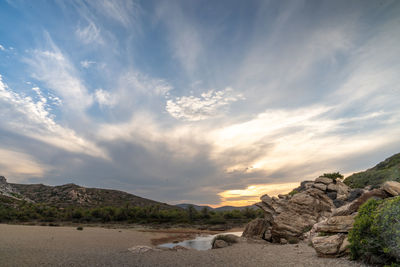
[166,87,243,121]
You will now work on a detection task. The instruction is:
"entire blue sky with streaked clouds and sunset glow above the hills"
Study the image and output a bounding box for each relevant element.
[0,0,400,206]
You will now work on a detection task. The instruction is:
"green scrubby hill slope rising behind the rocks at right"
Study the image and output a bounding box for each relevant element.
[344,153,400,188]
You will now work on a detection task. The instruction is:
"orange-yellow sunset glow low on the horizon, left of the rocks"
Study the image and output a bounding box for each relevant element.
[216,182,300,208]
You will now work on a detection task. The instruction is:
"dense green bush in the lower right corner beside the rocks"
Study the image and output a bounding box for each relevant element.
[349,197,400,264]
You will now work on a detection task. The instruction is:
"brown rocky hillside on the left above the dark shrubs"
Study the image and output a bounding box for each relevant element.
[0,176,176,209]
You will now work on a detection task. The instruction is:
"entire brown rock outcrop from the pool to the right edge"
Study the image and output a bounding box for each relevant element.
[243,177,400,257]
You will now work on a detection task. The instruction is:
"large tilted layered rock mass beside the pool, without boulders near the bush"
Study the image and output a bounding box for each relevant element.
[243,177,351,243]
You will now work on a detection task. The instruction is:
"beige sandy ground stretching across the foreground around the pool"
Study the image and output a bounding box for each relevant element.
[0,224,366,267]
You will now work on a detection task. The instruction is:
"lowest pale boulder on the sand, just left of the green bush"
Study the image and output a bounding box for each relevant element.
[311,234,345,257]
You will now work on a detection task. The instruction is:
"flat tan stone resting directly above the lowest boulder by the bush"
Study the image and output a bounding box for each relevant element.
[316,215,354,233]
